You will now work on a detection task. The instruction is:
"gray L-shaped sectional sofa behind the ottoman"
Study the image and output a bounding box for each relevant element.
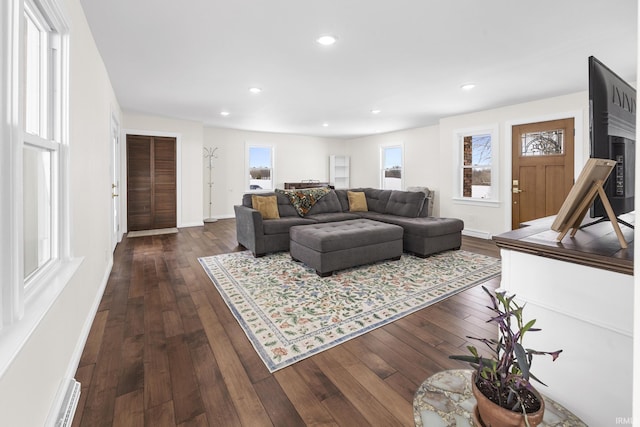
[234,188,464,257]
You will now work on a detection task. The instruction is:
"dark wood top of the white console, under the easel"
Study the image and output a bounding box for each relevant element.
[493,213,635,275]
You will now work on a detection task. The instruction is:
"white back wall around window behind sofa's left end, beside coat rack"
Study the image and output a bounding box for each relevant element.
[206,127,345,218]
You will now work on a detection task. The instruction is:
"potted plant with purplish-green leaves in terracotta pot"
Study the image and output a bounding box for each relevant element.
[449,286,562,427]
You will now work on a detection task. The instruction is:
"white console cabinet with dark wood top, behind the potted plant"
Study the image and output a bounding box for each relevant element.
[494,217,635,426]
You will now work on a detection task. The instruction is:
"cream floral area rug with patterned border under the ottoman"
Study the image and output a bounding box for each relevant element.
[199,250,500,372]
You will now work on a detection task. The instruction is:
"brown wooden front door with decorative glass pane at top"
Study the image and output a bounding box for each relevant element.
[511,118,574,230]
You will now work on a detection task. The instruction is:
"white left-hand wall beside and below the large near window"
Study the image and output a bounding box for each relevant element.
[0,0,120,426]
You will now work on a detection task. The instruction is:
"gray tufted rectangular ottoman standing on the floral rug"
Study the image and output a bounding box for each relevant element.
[289,219,403,277]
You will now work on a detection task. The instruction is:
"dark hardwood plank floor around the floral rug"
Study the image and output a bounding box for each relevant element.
[73,219,500,427]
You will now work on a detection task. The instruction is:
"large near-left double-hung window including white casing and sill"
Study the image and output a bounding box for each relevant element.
[0,0,74,364]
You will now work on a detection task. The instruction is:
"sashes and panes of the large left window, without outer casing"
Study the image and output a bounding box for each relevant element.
[22,0,62,293]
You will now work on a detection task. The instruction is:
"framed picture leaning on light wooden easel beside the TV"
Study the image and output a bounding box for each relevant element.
[551,158,627,248]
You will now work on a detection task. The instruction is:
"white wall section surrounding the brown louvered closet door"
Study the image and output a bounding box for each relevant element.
[121,112,204,230]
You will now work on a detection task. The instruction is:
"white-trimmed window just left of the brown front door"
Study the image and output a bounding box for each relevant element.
[454,128,498,202]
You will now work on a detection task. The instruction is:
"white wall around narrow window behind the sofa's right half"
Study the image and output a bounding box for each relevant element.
[346,126,441,215]
